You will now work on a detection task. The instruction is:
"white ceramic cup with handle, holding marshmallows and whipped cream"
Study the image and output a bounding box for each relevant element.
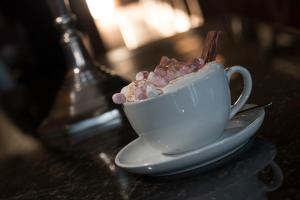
[124,62,252,156]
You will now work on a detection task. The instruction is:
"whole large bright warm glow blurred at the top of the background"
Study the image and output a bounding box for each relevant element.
[86,0,204,49]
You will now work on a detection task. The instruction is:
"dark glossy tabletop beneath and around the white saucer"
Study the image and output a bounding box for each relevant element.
[0,19,300,200]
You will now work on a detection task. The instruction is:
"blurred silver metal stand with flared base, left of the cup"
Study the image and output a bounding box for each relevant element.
[39,0,125,148]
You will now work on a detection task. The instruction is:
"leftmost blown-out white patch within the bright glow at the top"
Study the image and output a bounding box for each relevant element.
[86,0,116,25]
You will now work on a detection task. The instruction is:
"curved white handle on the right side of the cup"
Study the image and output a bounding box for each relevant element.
[225,66,252,119]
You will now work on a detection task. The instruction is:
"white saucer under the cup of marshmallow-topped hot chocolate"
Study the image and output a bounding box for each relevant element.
[115,104,265,176]
